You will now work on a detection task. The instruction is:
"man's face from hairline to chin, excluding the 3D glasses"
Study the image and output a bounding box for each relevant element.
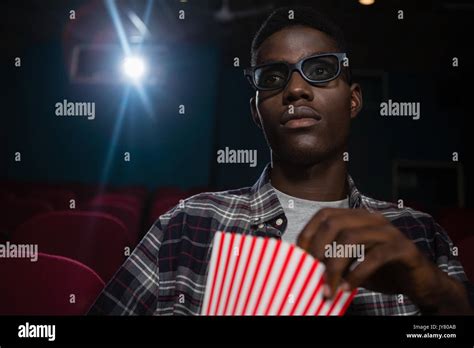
[251,26,361,165]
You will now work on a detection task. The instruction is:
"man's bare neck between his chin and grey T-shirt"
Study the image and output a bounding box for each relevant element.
[270,156,348,201]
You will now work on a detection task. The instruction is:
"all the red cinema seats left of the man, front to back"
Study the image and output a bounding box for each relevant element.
[0,185,209,315]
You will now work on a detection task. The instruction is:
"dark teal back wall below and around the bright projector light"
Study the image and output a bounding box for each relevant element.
[2,42,219,187]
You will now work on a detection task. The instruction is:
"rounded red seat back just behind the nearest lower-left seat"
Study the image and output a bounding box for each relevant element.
[12,211,133,282]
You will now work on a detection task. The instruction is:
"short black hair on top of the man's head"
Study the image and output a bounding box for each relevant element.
[250,6,351,84]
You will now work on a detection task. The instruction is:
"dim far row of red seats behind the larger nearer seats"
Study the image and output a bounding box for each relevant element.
[0,186,207,242]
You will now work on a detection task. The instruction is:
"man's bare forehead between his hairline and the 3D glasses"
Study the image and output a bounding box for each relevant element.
[257,26,338,64]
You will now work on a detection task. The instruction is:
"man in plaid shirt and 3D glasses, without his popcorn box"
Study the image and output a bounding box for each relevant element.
[91,8,474,315]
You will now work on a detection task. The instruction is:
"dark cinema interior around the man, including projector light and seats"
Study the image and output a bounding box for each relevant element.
[0,0,474,343]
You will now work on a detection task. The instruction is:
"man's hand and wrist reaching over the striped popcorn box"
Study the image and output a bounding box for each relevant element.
[297,208,472,314]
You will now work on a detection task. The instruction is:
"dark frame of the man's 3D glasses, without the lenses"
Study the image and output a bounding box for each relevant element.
[244,52,347,91]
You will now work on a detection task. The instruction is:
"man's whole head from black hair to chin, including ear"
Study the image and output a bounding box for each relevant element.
[250,7,362,166]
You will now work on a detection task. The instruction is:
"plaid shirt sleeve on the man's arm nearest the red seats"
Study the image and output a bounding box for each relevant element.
[88,219,163,315]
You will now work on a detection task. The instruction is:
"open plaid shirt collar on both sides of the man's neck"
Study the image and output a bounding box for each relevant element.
[250,163,365,224]
